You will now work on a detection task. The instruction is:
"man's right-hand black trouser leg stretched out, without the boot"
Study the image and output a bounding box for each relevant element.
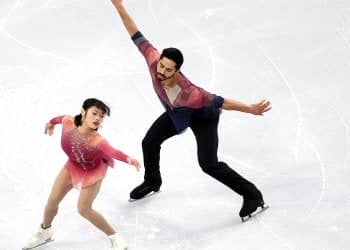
[190,115,260,198]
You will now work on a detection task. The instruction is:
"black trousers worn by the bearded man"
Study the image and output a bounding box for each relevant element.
[142,112,259,199]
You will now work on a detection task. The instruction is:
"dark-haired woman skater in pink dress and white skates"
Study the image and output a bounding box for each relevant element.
[23,98,140,250]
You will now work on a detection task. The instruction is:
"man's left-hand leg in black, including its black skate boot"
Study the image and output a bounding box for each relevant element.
[130,113,176,199]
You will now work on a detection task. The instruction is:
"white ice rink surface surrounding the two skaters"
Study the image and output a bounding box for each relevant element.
[0,0,350,250]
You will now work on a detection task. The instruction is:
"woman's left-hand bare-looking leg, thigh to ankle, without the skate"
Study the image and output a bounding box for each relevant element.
[42,168,72,228]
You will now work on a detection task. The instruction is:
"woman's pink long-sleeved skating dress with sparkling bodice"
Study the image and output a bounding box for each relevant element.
[50,116,128,188]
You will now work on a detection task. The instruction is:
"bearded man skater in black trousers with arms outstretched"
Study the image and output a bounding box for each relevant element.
[112,0,271,221]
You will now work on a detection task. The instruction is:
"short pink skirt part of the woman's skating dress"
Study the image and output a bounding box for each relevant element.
[64,160,108,189]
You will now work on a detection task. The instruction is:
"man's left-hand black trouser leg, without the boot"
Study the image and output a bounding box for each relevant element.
[142,113,176,180]
